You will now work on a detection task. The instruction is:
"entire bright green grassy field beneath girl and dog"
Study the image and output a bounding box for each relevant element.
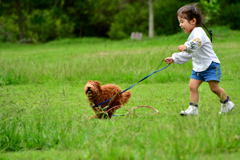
[0,27,240,160]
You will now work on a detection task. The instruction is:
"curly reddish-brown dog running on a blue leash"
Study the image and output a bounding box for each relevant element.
[85,81,132,119]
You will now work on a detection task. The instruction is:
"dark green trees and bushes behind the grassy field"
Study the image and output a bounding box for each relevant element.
[0,0,240,43]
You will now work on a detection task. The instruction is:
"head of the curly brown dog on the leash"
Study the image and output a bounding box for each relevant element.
[85,81,101,99]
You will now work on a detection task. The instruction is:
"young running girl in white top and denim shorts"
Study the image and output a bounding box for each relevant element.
[164,5,234,115]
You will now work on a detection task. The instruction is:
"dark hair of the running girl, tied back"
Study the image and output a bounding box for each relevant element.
[177,4,212,41]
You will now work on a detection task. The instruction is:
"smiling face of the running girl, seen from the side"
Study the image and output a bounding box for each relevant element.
[178,16,197,33]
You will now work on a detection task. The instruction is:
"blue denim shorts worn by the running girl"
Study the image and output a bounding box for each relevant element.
[190,62,221,82]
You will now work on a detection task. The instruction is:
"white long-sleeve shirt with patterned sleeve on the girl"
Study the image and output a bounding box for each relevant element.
[172,27,220,72]
